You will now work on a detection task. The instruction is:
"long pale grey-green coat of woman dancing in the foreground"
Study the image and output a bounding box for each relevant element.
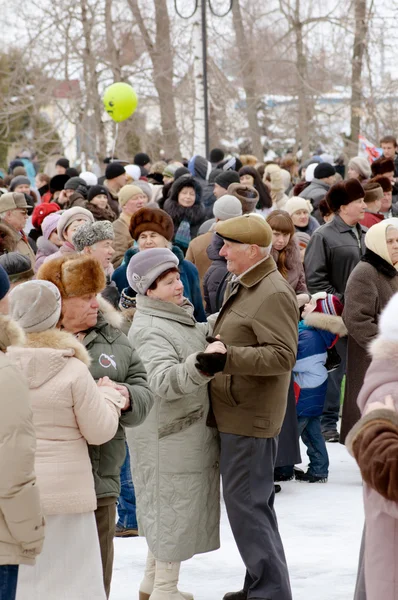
[127,296,220,562]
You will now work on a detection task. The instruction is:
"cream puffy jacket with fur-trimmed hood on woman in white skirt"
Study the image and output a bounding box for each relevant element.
[8,329,124,515]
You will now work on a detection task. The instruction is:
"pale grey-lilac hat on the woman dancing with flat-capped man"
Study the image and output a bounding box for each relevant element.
[127,248,178,296]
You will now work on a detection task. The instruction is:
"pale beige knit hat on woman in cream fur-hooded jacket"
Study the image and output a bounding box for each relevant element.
[10,281,61,333]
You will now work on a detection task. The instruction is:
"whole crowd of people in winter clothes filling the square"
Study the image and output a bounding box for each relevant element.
[0,142,398,600]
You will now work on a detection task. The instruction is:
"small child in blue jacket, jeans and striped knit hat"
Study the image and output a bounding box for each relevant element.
[293,292,347,483]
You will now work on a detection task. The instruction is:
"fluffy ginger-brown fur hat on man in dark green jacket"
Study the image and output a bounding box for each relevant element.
[36,255,106,298]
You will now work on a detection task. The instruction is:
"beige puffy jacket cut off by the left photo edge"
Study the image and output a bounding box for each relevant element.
[0,316,44,565]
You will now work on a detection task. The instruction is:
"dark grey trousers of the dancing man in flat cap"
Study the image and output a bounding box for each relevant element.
[220,433,292,600]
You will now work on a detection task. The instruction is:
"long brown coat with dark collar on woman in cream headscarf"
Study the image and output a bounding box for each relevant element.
[340,249,398,444]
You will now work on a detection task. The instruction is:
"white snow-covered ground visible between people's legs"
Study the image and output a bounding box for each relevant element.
[111,444,363,600]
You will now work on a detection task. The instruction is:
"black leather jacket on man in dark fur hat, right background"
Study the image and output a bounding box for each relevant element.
[304,215,366,302]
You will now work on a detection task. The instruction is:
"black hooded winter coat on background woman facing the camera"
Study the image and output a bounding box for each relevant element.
[164,175,205,252]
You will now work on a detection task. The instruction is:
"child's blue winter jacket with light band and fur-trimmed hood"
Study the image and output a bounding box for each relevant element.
[293,312,346,417]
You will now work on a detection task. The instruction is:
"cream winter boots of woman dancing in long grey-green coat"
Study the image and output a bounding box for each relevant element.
[139,550,193,600]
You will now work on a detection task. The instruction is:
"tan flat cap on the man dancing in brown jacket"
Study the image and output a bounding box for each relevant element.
[215,214,272,248]
